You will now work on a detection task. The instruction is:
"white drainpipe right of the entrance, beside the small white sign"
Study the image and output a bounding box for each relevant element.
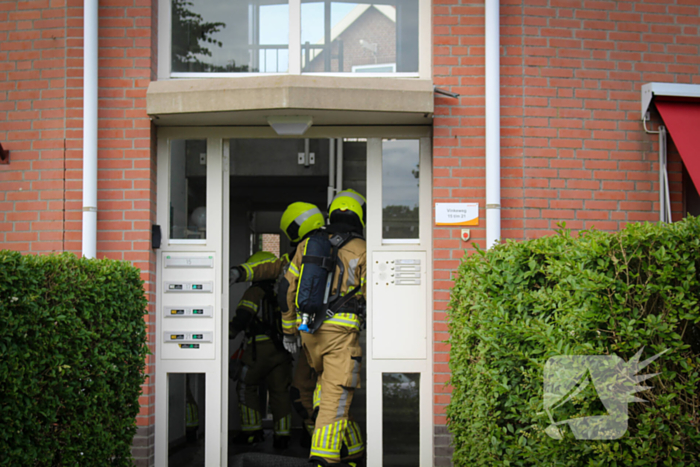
[484,0,501,248]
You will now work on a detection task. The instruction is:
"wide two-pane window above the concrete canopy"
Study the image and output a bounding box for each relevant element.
[168,0,422,78]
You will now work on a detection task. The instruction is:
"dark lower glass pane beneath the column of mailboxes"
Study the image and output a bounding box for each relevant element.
[168,373,206,467]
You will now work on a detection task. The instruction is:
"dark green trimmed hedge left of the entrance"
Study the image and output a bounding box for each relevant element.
[0,251,148,466]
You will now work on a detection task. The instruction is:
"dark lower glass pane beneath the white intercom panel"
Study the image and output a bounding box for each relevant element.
[382,373,420,467]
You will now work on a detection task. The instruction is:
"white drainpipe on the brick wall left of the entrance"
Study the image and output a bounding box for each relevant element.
[82,0,99,258]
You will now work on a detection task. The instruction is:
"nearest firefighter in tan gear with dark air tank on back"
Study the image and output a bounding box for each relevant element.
[283,190,367,465]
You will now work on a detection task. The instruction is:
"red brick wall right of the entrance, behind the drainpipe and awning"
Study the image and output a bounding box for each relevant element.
[433,0,700,465]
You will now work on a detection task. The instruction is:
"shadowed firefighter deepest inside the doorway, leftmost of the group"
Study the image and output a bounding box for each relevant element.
[229,251,292,449]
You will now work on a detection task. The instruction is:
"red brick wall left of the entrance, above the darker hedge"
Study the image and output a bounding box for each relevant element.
[0,0,157,465]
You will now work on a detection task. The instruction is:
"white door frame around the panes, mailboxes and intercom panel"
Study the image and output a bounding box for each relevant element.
[155,126,434,466]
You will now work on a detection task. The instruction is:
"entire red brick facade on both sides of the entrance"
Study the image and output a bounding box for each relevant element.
[0,0,700,466]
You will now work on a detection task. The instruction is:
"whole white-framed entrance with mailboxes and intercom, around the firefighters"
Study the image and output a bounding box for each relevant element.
[155,127,432,467]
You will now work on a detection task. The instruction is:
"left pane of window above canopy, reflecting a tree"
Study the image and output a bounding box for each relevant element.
[172,0,289,73]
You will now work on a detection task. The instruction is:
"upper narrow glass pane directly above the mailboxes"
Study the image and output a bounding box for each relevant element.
[170,140,207,239]
